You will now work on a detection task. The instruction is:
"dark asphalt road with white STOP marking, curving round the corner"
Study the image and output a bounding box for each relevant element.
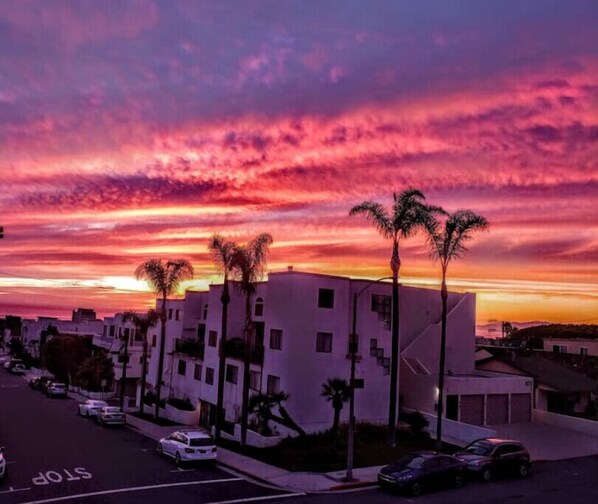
[0,370,598,504]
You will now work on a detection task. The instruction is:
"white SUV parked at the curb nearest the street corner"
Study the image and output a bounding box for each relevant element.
[157,429,218,465]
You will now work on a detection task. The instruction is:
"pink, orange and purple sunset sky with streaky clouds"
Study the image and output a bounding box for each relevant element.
[0,0,598,323]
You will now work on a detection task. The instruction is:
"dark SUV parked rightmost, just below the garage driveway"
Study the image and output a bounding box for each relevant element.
[454,438,532,481]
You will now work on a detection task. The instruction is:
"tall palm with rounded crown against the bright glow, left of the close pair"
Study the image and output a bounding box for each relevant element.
[135,259,193,420]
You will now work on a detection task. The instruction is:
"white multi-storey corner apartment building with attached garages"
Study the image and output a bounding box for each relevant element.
[148,268,532,432]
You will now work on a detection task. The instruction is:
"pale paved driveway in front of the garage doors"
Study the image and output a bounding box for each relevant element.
[492,423,598,460]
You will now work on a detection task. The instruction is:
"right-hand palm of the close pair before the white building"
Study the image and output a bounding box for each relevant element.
[231,233,272,446]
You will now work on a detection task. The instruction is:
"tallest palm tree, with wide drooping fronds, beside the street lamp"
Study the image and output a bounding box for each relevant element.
[349,188,441,446]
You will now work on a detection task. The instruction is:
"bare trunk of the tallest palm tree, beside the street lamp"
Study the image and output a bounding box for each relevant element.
[387,240,401,446]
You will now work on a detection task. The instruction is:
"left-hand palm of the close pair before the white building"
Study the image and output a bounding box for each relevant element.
[208,234,237,441]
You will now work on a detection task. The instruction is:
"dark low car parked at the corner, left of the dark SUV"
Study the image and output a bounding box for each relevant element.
[378,451,465,496]
